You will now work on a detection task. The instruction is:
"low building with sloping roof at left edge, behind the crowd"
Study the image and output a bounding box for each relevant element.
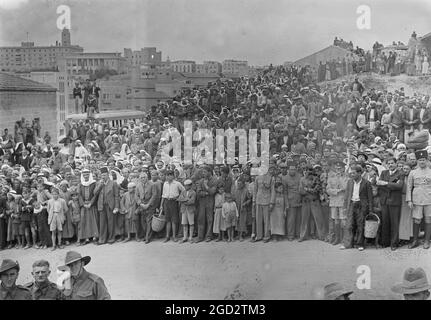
[0,72,59,143]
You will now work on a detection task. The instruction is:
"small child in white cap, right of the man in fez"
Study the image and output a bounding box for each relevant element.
[120,182,139,242]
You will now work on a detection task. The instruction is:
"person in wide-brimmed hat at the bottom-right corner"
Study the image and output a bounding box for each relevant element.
[392,268,431,300]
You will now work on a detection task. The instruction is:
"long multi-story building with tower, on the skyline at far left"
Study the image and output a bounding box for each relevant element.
[0,29,84,72]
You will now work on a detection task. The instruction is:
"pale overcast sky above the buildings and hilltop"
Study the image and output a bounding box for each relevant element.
[0,0,431,65]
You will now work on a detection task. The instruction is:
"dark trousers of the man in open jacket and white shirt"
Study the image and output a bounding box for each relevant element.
[343,202,367,248]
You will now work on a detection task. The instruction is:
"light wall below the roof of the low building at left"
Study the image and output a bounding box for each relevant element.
[0,91,58,143]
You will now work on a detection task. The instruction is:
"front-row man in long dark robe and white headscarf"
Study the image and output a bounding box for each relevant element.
[78,170,99,244]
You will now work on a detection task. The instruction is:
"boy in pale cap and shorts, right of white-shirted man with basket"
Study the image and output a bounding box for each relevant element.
[178,179,196,243]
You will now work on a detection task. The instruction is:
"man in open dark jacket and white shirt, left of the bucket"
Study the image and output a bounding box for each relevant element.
[340,165,373,251]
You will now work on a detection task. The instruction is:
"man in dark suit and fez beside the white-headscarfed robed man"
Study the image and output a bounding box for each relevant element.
[97,167,120,244]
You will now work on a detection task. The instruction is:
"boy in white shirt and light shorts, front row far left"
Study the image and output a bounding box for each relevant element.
[47,188,68,251]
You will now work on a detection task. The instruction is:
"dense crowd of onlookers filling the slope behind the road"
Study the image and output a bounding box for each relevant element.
[0,66,431,256]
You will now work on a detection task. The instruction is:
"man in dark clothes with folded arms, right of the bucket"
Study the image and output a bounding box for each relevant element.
[377,158,404,251]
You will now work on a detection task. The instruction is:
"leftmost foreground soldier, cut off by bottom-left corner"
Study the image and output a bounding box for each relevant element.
[0,259,31,300]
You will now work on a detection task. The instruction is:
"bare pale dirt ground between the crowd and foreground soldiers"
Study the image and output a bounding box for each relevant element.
[0,240,431,300]
